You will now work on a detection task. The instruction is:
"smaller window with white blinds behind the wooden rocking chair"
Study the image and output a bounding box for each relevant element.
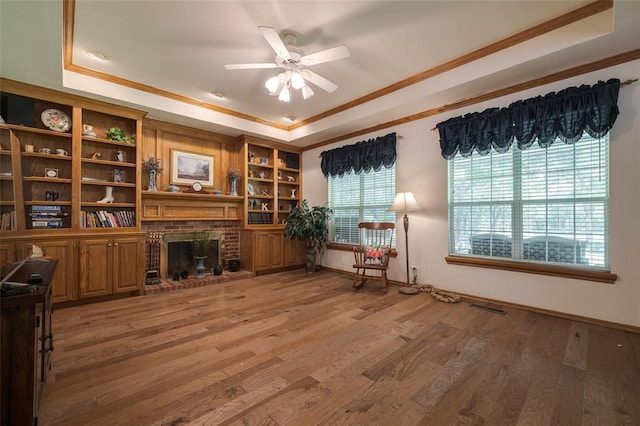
[328,165,396,247]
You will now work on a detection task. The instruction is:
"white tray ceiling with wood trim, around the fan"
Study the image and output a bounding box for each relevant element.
[0,0,640,147]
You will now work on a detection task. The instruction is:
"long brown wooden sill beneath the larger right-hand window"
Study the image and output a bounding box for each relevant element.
[444,256,618,284]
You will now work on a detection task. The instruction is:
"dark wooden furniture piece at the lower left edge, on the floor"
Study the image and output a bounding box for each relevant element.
[0,259,58,426]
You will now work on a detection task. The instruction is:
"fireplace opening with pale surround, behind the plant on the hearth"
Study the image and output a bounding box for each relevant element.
[160,231,224,278]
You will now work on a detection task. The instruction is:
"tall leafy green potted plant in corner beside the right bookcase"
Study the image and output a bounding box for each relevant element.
[284,200,333,272]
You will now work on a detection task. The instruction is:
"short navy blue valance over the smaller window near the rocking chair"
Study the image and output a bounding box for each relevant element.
[320,133,397,177]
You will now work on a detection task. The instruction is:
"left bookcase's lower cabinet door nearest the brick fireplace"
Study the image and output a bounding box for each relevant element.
[113,237,144,293]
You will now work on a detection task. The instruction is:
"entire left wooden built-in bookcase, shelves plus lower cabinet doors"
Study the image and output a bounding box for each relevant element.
[0,79,144,303]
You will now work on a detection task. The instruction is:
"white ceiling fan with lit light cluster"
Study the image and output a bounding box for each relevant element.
[224,27,351,102]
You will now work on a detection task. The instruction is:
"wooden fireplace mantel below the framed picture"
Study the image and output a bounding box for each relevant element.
[142,191,244,221]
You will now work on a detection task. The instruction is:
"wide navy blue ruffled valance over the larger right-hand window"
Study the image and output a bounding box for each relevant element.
[436,79,620,160]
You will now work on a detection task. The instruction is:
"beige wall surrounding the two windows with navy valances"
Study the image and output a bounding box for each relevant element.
[303,61,640,326]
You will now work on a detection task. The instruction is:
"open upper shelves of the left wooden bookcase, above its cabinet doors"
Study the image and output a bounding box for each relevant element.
[0,79,144,235]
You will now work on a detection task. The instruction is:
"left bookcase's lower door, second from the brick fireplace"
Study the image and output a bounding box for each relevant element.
[79,238,113,298]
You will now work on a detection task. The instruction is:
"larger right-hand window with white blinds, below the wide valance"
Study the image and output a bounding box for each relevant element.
[449,133,609,269]
